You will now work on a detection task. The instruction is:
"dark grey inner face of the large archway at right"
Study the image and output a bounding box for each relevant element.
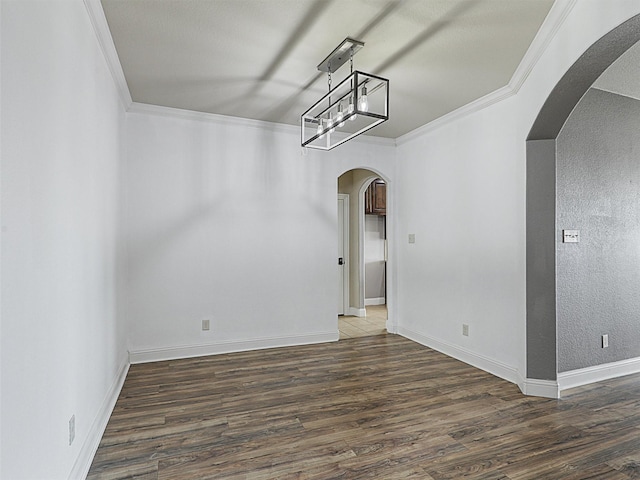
[526,15,640,381]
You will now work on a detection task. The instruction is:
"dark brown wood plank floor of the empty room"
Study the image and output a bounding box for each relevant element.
[88,335,640,480]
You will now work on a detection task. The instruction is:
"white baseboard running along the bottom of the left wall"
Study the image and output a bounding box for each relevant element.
[69,357,130,480]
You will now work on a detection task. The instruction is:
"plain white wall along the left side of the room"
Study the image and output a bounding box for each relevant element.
[0,0,127,480]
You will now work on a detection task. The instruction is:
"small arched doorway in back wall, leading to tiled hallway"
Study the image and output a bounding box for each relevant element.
[338,168,392,338]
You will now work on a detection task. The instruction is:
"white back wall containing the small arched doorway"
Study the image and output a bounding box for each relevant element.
[127,106,395,362]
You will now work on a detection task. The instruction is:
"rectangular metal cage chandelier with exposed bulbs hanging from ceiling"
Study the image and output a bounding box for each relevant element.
[300,38,389,150]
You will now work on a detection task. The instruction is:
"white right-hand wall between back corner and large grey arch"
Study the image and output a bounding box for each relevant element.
[396,0,640,388]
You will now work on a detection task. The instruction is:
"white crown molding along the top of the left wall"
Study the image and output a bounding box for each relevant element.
[84,0,133,110]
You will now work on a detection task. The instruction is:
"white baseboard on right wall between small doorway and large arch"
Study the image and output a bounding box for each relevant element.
[398,326,521,385]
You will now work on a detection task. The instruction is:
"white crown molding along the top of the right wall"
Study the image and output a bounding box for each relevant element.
[396,0,577,145]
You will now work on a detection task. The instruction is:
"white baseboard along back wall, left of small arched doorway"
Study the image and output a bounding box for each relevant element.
[129,330,340,364]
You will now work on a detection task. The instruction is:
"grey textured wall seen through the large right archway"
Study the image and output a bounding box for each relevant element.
[556,89,640,372]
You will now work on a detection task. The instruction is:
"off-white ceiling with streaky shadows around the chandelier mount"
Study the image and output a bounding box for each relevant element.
[102,0,553,138]
